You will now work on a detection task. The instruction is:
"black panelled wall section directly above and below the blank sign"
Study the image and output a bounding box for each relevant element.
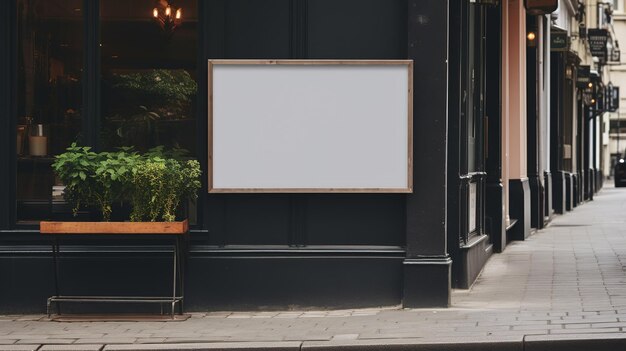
[201,0,407,246]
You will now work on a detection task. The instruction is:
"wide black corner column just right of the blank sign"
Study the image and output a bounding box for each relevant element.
[402,0,451,307]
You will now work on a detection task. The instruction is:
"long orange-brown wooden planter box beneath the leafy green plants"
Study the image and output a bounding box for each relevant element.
[39,219,189,235]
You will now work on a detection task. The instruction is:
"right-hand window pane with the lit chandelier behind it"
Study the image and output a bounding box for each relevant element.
[100,0,197,155]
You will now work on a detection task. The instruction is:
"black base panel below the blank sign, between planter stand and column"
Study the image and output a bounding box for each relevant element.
[185,256,402,311]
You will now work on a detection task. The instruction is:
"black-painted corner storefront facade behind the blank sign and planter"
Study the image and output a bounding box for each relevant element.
[0,0,498,313]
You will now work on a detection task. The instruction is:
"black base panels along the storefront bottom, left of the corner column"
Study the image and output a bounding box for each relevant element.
[0,247,402,314]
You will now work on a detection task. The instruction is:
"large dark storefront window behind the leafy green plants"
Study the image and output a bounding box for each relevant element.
[15,0,198,224]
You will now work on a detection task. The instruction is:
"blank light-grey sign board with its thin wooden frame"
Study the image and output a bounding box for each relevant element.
[209,60,412,192]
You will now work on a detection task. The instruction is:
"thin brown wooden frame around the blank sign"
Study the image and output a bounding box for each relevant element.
[207,59,413,193]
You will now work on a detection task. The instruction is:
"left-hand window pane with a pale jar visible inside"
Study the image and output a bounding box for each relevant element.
[16,0,83,223]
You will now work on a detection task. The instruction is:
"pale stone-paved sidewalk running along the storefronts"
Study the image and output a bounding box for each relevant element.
[0,186,626,351]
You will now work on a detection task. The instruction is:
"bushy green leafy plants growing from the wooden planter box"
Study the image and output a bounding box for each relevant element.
[52,143,201,222]
